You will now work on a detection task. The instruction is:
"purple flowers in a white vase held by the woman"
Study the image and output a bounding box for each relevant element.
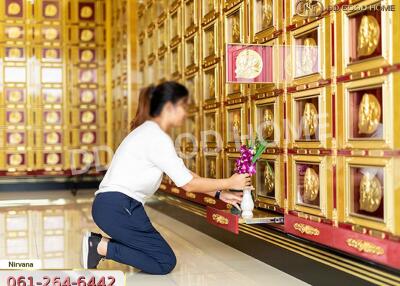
[234,137,267,218]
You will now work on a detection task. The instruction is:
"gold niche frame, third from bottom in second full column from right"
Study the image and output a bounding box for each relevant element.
[288,16,331,85]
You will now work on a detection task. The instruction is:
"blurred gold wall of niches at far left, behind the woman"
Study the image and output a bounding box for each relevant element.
[0,0,115,175]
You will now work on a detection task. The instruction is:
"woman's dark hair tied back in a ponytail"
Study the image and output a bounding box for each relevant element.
[131,81,189,130]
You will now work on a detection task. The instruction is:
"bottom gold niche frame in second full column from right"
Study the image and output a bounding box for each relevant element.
[288,155,333,219]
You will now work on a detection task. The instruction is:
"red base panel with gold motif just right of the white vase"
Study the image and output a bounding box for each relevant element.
[285,214,333,246]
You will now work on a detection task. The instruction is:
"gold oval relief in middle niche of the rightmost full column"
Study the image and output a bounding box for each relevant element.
[358,93,381,134]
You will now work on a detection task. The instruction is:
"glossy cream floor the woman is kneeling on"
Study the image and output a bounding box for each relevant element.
[0,191,306,286]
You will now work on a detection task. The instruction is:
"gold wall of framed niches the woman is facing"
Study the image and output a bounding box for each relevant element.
[138,0,400,237]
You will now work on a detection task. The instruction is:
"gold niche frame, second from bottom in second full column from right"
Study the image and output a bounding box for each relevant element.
[287,86,333,148]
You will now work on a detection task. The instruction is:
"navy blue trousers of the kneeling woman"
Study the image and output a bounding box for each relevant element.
[92,192,176,274]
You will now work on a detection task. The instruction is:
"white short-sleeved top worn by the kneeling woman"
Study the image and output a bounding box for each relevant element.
[95,120,193,204]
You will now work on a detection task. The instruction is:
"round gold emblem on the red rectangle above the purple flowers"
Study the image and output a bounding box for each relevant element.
[235,49,263,79]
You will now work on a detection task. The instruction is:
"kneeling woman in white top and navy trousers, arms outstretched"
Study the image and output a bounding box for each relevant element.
[82,82,251,274]
